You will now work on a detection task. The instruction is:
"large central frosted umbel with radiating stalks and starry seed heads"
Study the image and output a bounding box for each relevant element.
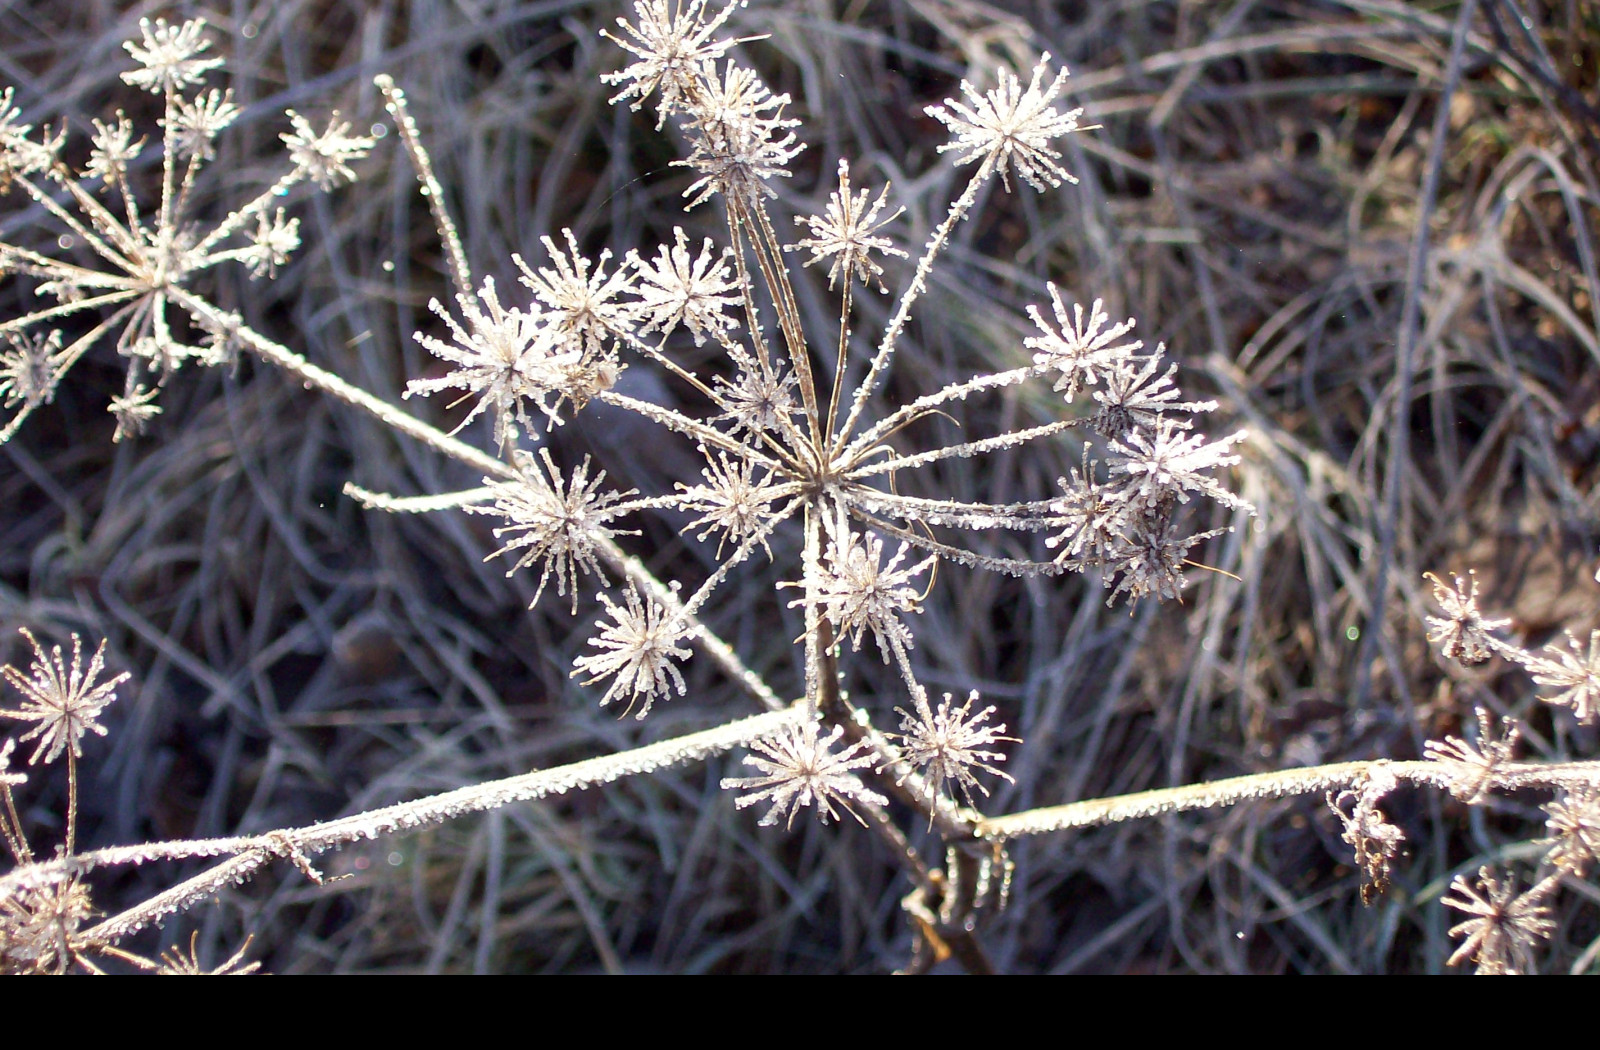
[390,3,1248,758]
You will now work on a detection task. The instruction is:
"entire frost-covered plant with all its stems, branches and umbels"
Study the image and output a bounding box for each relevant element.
[0,10,1600,972]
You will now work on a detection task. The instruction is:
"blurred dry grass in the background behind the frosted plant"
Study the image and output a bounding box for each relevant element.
[0,0,1600,972]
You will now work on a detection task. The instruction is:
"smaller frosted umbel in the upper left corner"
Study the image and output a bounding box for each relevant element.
[0,19,373,442]
